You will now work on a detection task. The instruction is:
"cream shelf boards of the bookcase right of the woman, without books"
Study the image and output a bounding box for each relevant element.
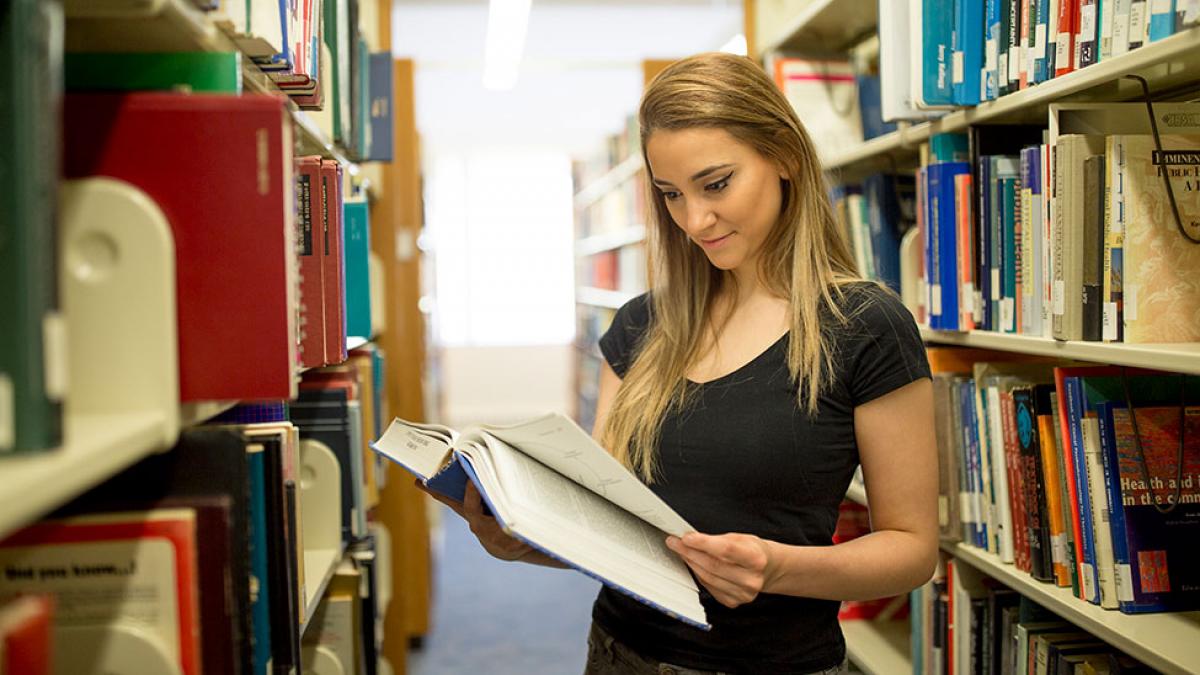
[746,0,1200,673]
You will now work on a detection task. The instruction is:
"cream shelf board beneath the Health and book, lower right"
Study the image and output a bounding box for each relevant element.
[942,544,1200,674]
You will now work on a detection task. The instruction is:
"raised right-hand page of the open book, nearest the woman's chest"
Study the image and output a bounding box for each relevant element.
[470,413,695,537]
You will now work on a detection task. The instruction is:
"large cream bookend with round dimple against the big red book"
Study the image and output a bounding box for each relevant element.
[59,177,180,449]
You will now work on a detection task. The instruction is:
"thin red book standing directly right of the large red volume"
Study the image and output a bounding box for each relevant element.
[296,155,326,368]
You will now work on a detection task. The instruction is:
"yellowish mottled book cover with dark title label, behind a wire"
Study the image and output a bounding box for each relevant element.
[1112,135,1200,342]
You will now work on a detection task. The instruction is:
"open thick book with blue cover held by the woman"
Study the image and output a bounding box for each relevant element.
[371,413,709,629]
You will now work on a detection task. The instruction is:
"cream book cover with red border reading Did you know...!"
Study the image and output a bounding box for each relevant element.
[0,508,204,675]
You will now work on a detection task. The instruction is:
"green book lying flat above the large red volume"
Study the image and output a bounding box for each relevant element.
[64,52,241,94]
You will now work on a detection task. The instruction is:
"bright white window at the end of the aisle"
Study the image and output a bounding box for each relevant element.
[426,150,575,346]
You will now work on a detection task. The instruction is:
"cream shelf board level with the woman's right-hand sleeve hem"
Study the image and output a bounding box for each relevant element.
[920,328,1200,375]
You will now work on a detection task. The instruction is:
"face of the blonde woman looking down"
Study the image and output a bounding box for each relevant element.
[646,129,784,271]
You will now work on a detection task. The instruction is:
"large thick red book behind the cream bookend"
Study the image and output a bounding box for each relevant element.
[64,92,296,401]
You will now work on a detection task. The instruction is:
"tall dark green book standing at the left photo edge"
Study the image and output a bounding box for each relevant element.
[0,0,66,455]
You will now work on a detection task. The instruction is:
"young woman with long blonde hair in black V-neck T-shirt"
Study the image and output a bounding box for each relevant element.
[429,54,937,675]
